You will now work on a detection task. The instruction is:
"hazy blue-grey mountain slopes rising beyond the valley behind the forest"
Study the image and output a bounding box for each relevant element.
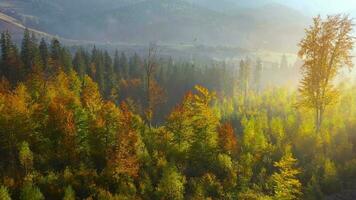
[0,0,310,52]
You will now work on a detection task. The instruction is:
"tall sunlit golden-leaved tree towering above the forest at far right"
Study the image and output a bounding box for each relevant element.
[298,15,354,132]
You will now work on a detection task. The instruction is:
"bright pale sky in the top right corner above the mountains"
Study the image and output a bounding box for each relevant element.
[273,0,356,15]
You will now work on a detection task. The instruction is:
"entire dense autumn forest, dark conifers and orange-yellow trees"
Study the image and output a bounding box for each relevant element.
[0,16,356,200]
